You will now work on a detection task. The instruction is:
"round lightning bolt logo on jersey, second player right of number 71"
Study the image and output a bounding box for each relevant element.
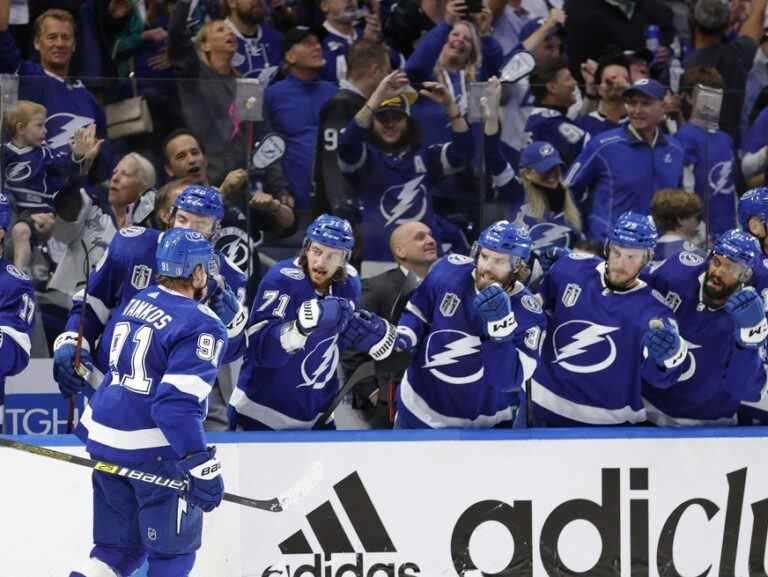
[552,320,619,374]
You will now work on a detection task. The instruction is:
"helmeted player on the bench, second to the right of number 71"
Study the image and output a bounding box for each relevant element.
[531,212,687,427]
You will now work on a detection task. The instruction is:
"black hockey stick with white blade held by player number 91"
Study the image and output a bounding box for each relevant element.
[0,436,322,513]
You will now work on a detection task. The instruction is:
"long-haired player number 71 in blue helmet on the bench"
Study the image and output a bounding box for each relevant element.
[230,214,395,430]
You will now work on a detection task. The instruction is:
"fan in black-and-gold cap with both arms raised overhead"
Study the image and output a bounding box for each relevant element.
[339,71,472,276]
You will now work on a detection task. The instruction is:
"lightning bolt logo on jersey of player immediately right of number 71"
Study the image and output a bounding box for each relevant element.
[423,329,483,385]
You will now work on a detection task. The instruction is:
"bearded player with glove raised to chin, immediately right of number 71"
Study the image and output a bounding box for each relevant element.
[395,220,546,429]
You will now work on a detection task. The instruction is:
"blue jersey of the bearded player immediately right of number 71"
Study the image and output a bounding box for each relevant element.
[398,258,546,428]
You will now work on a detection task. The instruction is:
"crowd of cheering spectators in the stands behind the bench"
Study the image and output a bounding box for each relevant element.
[0,0,768,428]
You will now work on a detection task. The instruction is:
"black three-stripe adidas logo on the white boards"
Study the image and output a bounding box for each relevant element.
[261,471,421,577]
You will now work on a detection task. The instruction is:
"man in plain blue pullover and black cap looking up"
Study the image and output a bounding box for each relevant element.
[264,27,338,212]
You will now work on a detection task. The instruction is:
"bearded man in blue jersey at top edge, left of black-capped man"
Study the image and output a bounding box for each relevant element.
[222,0,283,78]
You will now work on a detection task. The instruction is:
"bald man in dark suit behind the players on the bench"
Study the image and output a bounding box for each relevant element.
[343,221,437,429]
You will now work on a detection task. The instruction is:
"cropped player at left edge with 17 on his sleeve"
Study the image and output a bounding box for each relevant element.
[0,193,35,433]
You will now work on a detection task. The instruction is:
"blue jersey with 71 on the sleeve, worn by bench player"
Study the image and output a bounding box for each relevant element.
[230,259,361,430]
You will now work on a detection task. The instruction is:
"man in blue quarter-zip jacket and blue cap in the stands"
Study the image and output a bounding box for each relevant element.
[566,79,684,240]
